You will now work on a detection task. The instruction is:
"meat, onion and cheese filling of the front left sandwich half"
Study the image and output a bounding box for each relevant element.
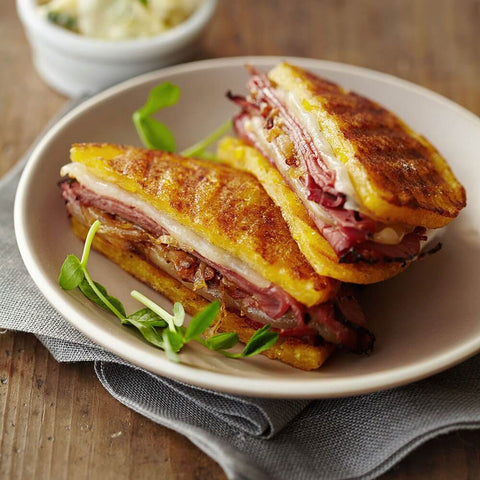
[60,163,374,353]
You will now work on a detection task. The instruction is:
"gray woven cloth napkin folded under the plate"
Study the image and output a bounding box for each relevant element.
[0,132,480,480]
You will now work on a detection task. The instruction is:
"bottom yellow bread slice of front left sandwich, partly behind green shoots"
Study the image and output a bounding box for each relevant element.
[71,217,334,370]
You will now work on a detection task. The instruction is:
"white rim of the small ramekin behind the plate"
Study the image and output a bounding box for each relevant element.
[16,0,218,58]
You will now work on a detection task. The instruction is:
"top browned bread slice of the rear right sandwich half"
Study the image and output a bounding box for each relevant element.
[268,63,466,228]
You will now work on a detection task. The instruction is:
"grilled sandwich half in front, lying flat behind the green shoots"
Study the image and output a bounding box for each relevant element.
[60,144,374,370]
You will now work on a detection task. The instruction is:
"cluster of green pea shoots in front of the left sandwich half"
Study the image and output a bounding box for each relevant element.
[58,220,278,363]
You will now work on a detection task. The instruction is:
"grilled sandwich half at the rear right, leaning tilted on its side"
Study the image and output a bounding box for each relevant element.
[223,63,466,283]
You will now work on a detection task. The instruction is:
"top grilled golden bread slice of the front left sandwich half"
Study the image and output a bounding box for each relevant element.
[70,144,338,307]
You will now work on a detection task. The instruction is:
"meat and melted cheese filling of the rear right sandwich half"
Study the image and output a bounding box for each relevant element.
[228,69,427,263]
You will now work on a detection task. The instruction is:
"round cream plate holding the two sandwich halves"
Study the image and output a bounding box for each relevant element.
[15,57,480,398]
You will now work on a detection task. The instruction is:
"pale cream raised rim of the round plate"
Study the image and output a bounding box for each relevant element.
[13,56,480,399]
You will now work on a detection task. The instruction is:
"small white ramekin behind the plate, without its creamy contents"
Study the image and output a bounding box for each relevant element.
[17,0,217,97]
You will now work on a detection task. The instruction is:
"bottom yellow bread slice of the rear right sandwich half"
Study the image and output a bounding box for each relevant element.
[217,137,406,284]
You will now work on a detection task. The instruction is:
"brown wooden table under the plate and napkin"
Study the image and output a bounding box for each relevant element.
[0,0,480,480]
